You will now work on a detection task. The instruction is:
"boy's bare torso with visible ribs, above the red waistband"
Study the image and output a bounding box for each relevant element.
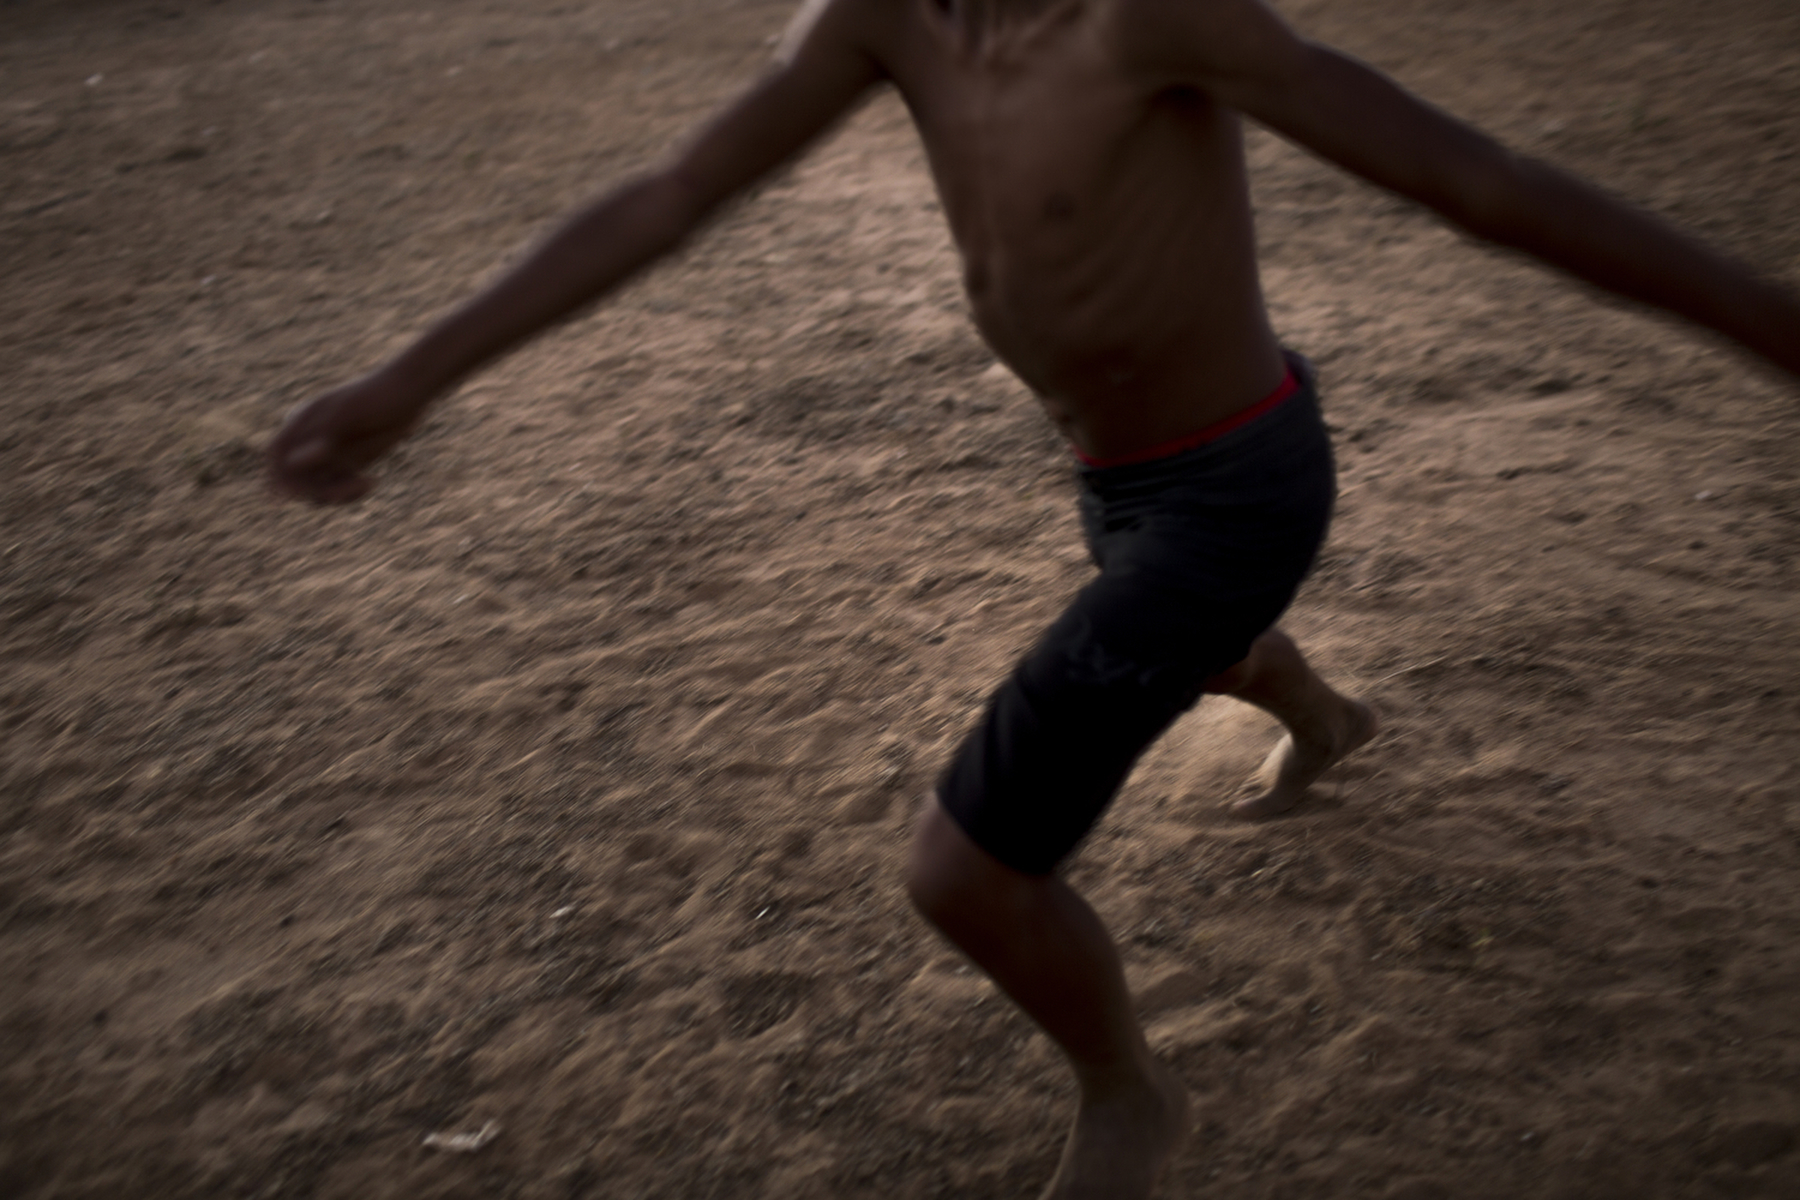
[882,0,1285,457]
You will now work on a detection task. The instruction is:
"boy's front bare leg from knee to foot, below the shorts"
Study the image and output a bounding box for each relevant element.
[907,799,1188,1200]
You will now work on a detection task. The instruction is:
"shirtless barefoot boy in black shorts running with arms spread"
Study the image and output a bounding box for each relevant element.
[270,0,1800,1198]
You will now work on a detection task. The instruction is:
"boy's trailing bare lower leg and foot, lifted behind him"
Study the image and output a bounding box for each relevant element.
[1206,630,1379,819]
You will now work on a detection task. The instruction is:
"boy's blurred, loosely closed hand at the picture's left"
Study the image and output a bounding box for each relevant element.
[266,372,430,504]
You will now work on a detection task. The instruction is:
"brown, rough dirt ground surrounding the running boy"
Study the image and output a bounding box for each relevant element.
[0,0,1800,1200]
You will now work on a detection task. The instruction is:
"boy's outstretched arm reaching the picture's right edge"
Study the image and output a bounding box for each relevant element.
[1127,0,1800,378]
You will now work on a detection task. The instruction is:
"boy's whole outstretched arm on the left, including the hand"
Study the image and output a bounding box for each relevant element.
[268,5,882,504]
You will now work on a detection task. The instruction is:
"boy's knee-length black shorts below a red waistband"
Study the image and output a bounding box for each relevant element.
[938,358,1336,874]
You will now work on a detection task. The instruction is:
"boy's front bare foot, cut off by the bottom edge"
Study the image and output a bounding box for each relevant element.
[1042,1063,1188,1200]
